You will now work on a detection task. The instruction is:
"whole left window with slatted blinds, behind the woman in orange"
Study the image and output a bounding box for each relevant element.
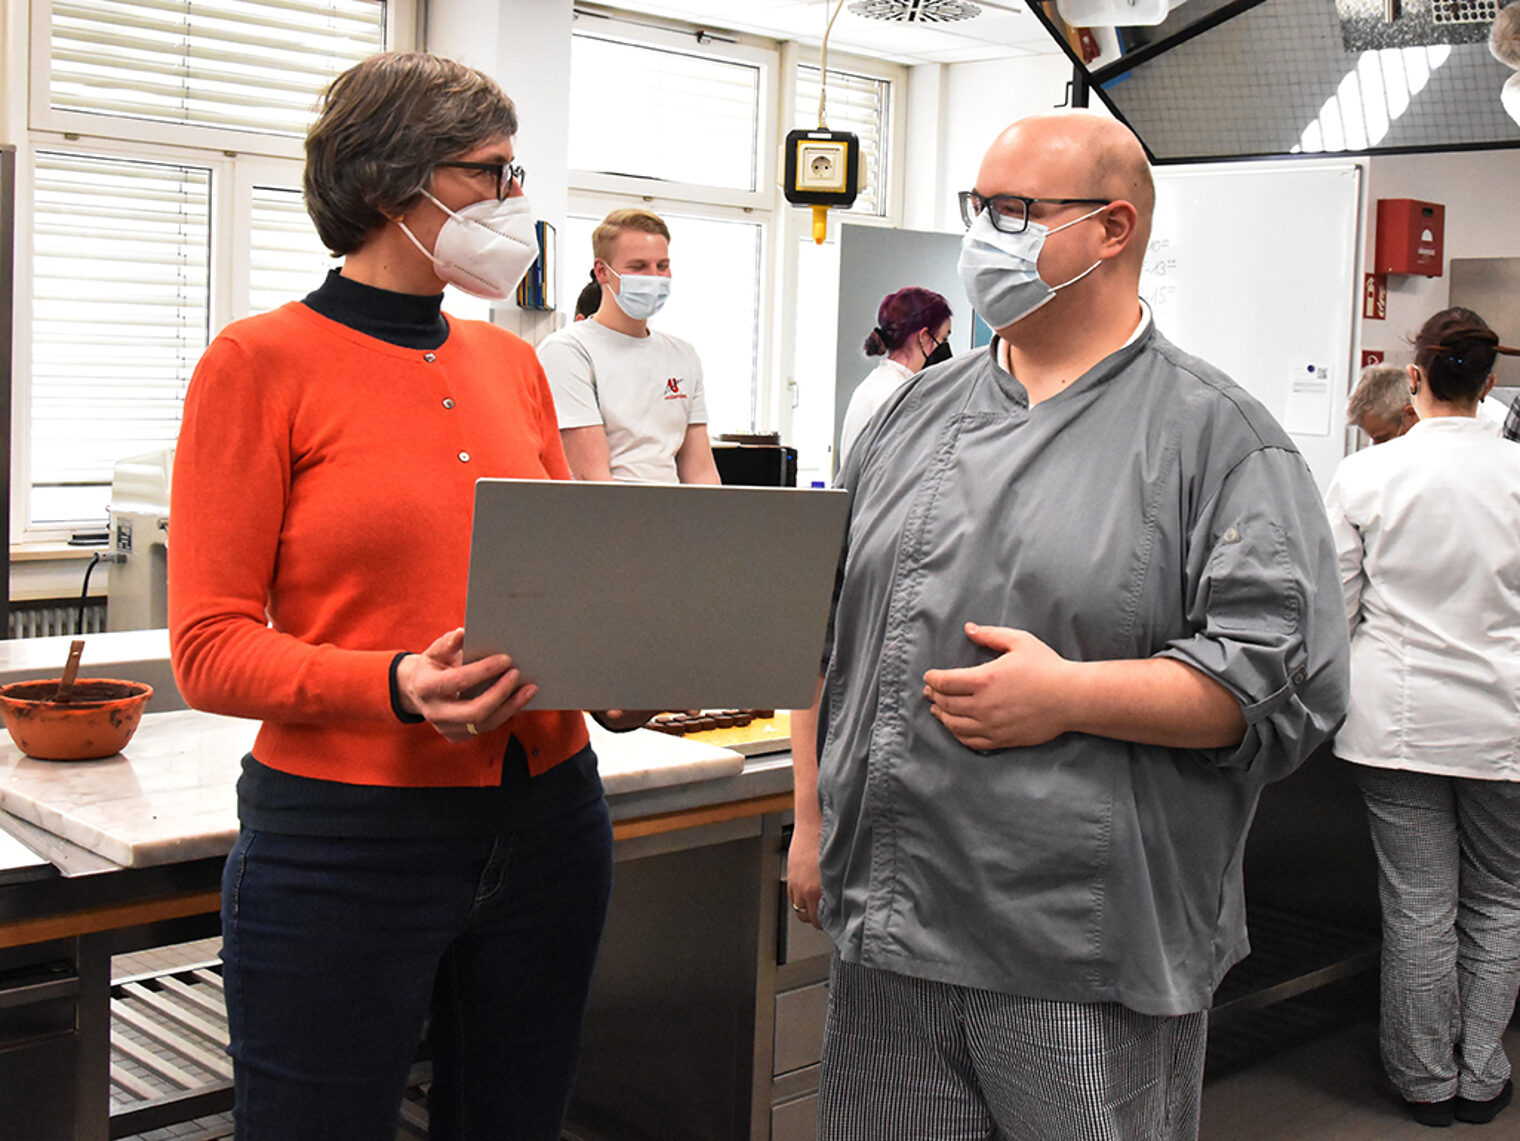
[6,0,413,541]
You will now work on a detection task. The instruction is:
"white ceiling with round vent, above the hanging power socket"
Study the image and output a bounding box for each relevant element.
[580,0,1061,64]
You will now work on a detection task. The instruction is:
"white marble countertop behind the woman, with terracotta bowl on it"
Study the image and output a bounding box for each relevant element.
[0,710,745,868]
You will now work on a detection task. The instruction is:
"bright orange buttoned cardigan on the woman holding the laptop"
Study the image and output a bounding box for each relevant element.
[169,302,587,787]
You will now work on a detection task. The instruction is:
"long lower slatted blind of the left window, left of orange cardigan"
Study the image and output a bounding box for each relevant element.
[30,152,211,524]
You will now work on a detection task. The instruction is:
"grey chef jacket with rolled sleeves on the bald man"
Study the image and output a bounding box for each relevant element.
[818,314,1348,1013]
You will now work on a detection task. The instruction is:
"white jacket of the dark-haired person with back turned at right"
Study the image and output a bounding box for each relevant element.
[1325,416,1520,781]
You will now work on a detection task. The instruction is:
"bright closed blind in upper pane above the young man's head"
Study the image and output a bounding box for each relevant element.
[570,35,760,190]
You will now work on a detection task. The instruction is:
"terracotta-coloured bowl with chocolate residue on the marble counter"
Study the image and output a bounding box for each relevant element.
[0,678,154,761]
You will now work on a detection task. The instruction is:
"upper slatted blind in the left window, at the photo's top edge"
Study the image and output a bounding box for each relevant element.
[49,0,385,135]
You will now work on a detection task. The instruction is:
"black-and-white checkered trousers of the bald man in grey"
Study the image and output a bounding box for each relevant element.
[818,956,1207,1141]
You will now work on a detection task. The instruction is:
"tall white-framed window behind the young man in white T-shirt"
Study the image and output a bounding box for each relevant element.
[559,26,780,439]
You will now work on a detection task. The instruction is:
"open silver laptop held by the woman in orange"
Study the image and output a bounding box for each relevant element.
[465,479,850,710]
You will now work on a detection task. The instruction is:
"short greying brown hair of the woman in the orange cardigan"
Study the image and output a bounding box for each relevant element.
[304,52,517,254]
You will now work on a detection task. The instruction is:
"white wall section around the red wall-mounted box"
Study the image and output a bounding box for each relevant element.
[1362,150,1520,365]
